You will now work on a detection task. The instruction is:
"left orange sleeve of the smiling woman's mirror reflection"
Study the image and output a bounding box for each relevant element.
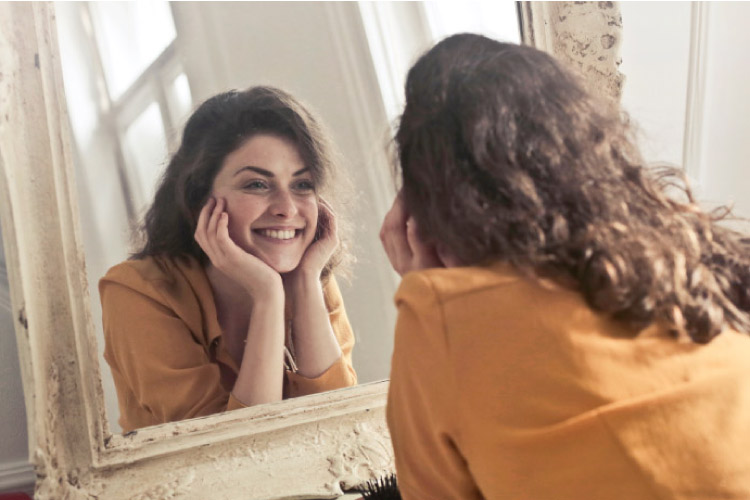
[100,280,229,430]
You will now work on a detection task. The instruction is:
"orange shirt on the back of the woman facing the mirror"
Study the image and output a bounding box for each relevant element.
[387,264,750,500]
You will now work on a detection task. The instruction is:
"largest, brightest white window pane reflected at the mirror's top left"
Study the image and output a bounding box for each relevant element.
[89,1,175,100]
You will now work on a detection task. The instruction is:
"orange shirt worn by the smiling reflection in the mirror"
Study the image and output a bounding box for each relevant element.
[99,257,357,431]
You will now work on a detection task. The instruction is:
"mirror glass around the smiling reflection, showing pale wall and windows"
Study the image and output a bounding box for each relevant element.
[55,2,520,433]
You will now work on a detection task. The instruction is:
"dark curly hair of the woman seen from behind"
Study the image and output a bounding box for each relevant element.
[396,34,750,343]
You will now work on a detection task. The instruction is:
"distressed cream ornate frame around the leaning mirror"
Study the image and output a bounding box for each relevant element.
[0,2,619,500]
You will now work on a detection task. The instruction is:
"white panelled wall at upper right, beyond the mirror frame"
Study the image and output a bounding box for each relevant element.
[620,2,750,217]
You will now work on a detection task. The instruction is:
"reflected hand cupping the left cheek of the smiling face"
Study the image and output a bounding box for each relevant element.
[194,198,284,299]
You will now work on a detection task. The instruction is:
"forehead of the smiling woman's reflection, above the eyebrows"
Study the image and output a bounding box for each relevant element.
[217,134,305,177]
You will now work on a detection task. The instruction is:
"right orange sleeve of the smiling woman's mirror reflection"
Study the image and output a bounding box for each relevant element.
[286,276,357,397]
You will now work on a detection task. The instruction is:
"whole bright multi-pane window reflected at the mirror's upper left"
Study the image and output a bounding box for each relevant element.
[56,1,192,219]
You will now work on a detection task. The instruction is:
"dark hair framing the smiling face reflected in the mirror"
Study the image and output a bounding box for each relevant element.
[131,87,350,279]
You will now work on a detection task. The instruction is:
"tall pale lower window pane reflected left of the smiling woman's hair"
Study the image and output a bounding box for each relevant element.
[124,102,167,216]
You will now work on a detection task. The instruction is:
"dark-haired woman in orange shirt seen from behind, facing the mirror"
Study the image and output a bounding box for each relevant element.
[381,34,750,500]
